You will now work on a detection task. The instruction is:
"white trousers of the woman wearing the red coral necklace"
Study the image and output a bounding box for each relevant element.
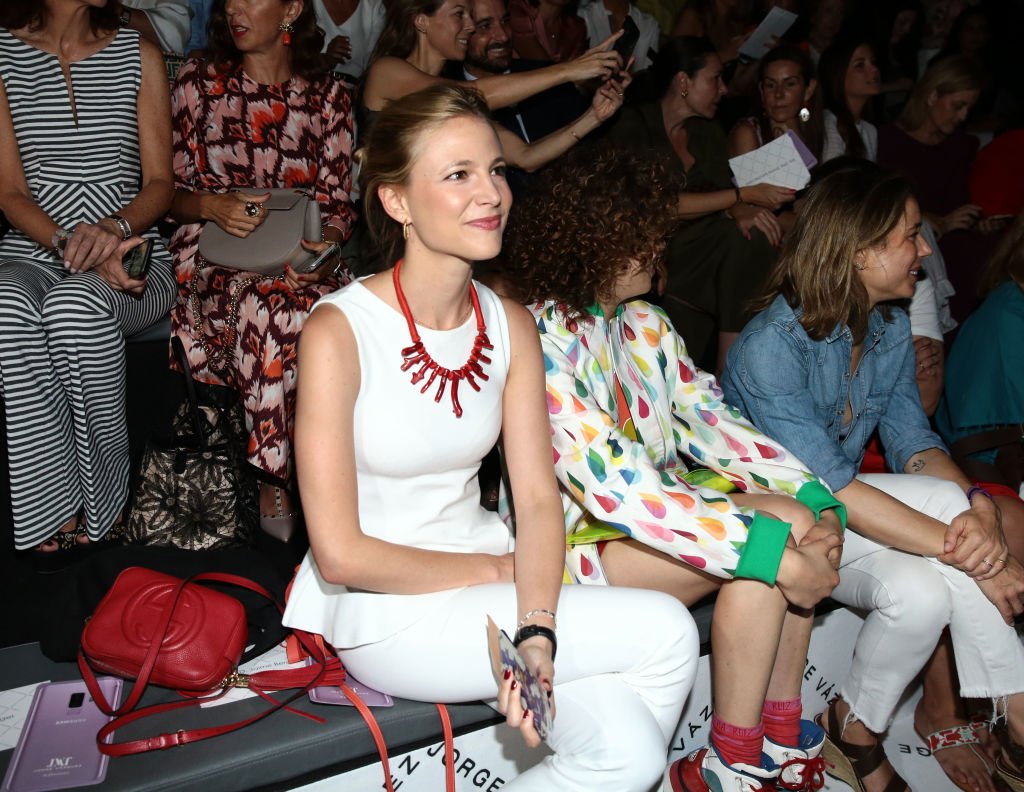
[339,583,699,792]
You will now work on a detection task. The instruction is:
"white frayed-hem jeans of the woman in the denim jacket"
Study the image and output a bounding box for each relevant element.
[833,473,1024,732]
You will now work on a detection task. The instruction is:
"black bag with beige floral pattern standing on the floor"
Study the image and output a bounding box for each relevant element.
[126,337,259,550]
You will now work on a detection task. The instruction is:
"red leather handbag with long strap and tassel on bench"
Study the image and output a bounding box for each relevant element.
[78,567,455,792]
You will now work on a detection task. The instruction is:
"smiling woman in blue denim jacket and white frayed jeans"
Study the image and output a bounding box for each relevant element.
[722,169,1024,792]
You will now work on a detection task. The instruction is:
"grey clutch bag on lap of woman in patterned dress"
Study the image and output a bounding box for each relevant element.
[199,187,322,275]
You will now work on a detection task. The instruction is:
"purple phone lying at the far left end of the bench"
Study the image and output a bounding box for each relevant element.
[2,676,122,792]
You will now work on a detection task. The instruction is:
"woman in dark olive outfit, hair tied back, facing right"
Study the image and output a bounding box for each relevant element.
[608,37,795,371]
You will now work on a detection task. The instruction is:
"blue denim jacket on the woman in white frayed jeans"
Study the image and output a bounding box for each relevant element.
[721,296,946,492]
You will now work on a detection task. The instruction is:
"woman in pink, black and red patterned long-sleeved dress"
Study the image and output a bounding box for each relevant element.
[171,0,354,527]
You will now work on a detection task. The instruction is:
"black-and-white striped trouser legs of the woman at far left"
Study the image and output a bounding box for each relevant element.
[0,259,177,549]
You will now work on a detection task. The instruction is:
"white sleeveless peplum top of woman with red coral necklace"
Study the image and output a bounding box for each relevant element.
[284,281,513,649]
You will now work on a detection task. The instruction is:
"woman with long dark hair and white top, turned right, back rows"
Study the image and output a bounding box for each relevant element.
[818,33,882,162]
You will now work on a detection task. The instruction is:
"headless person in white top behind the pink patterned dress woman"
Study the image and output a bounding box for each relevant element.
[312,0,384,80]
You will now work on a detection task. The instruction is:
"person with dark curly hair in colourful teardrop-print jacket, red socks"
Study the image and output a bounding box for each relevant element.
[506,143,843,792]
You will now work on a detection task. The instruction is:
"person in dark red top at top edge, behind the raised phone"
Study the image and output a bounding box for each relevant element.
[509,0,597,64]
